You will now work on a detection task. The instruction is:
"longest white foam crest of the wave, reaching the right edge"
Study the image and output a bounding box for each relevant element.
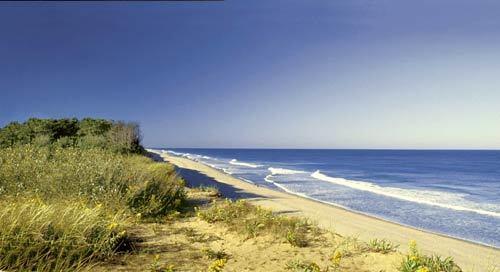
[311,170,500,217]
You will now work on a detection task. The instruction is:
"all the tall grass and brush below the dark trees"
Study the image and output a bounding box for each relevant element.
[0,145,185,271]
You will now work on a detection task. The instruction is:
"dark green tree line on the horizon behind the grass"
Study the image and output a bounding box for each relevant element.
[0,118,144,153]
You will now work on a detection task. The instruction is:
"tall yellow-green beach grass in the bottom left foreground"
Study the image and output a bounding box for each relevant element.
[0,199,131,271]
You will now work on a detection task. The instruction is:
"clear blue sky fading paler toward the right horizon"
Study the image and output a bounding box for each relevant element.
[0,0,500,148]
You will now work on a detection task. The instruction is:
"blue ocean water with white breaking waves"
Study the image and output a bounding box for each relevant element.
[156,149,500,248]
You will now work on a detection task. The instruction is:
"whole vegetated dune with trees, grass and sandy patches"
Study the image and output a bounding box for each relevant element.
[0,118,461,272]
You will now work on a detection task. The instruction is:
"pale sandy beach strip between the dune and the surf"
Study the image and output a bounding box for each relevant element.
[157,154,500,271]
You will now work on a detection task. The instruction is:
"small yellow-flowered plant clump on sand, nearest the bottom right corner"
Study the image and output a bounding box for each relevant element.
[399,241,462,272]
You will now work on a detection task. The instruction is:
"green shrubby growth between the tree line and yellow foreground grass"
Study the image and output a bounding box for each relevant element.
[0,145,184,211]
